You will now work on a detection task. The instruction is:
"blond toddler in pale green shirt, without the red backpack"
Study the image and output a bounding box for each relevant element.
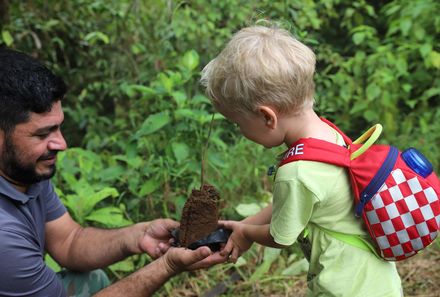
[201,26,401,297]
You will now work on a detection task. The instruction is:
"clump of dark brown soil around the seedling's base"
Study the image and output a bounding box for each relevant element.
[180,184,220,247]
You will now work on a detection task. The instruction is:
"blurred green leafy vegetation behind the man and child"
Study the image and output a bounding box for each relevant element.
[0,0,440,296]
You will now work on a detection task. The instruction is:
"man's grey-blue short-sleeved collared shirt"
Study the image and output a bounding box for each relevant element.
[0,177,66,297]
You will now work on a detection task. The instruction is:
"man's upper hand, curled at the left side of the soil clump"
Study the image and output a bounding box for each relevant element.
[139,219,179,259]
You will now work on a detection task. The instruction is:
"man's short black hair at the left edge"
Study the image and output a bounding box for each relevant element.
[0,48,67,133]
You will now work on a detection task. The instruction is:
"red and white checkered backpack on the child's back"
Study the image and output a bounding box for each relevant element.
[279,119,440,261]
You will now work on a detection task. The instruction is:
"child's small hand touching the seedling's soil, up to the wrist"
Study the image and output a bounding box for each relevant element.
[219,221,253,263]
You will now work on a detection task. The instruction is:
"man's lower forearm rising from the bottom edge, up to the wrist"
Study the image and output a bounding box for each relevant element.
[94,257,175,297]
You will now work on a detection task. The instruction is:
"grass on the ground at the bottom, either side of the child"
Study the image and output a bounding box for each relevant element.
[154,242,440,297]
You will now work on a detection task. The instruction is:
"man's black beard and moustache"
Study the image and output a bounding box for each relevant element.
[0,136,57,185]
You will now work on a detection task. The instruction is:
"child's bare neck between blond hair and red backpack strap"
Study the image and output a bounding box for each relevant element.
[282,109,336,147]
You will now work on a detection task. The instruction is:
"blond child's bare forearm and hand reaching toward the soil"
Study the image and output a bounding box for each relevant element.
[220,221,285,263]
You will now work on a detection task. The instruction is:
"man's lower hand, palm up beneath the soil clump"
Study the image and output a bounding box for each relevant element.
[158,246,228,275]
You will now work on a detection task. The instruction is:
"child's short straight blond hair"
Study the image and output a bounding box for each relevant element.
[201,26,315,114]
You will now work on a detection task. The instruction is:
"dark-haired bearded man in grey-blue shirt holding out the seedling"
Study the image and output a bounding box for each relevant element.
[0,49,226,297]
